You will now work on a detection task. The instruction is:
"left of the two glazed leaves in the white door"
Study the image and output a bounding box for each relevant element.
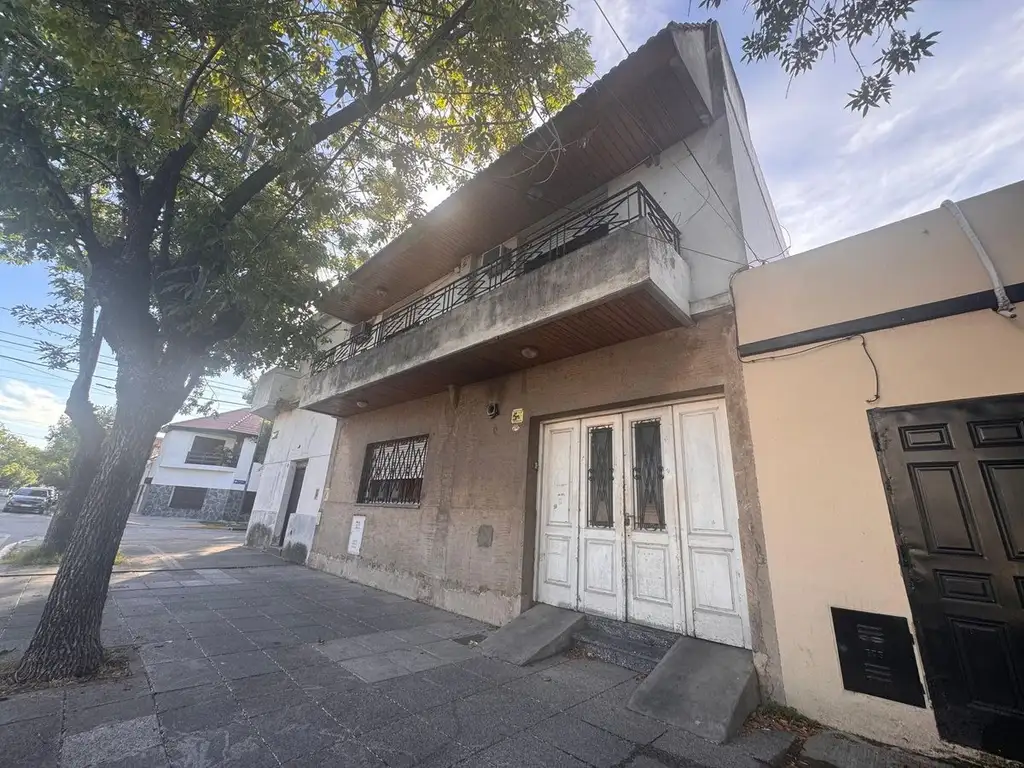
[580,414,626,621]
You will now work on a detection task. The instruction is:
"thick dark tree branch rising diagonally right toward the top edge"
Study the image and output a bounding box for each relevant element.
[220,0,475,227]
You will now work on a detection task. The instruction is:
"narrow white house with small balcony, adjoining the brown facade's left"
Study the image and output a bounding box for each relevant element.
[246,369,337,562]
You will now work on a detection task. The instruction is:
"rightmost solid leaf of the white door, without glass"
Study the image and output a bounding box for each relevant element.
[673,400,751,648]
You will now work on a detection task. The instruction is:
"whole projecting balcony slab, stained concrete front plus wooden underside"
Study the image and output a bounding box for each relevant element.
[300,220,691,416]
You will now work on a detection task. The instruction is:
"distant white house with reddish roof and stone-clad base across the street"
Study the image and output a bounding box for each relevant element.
[138,409,263,520]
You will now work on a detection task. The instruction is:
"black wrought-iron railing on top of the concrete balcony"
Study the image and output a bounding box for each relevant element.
[312,181,679,373]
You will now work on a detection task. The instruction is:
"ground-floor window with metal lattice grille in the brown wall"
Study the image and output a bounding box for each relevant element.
[356,435,427,504]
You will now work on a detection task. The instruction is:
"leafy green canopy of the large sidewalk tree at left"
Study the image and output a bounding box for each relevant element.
[0,0,592,374]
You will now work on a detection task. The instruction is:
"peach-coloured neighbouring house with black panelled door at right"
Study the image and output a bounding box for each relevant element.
[734,182,1024,760]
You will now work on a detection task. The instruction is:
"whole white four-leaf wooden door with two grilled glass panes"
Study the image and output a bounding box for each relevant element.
[535,400,750,647]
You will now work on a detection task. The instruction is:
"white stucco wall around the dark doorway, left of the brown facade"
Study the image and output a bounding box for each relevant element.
[249,409,337,552]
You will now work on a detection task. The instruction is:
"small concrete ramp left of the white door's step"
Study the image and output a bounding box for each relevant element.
[480,603,587,667]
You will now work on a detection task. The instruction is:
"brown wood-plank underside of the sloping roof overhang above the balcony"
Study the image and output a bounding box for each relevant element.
[321,22,714,323]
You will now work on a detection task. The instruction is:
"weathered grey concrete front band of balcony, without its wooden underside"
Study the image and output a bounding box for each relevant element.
[301,220,690,407]
